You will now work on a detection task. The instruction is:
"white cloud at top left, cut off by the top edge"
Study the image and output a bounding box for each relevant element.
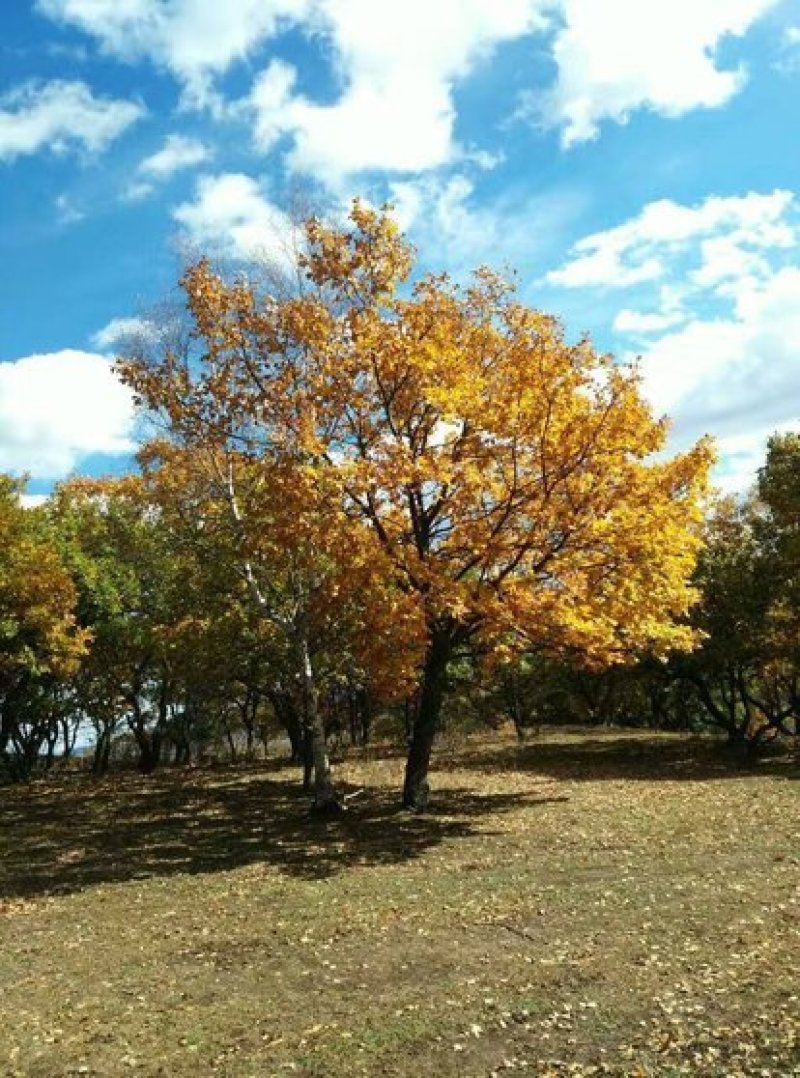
[38,0,312,101]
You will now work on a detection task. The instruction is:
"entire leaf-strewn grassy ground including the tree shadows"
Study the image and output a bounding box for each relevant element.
[0,731,800,1078]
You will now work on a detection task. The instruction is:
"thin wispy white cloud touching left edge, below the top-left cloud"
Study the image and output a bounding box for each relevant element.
[0,81,144,160]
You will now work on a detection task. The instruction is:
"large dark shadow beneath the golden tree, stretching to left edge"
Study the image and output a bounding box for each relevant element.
[0,769,564,899]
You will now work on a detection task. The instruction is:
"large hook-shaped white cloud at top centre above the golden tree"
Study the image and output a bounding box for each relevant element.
[250,0,550,183]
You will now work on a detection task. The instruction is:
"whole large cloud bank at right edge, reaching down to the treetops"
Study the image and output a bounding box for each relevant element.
[548,191,800,489]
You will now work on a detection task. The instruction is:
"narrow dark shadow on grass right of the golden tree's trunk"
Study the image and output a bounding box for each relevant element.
[452,730,800,783]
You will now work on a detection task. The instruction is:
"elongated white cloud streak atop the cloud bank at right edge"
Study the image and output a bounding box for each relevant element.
[547,191,795,288]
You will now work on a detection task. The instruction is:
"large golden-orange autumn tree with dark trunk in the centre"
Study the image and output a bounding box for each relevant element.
[120,203,711,810]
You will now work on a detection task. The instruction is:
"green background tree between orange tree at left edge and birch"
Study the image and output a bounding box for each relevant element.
[51,476,211,772]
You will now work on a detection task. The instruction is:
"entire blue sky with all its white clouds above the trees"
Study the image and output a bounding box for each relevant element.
[0,0,800,494]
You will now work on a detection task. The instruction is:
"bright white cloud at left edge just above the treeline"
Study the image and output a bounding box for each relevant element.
[0,349,135,479]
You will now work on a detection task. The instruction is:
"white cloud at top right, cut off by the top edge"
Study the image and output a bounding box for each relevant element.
[541,0,778,147]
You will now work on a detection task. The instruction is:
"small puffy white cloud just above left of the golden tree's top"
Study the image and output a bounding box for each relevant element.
[173,172,293,265]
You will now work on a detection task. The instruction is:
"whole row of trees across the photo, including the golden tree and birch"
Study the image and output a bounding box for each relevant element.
[0,203,800,811]
